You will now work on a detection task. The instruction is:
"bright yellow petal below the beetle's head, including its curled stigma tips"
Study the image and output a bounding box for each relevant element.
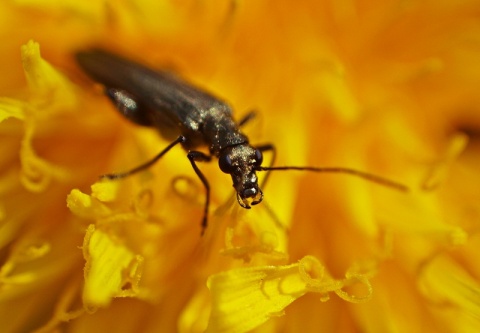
[207,256,372,332]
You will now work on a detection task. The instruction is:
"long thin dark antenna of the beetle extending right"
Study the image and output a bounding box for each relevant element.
[255,166,409,192]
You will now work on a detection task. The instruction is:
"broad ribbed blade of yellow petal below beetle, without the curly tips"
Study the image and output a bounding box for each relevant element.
[207,264,306,332]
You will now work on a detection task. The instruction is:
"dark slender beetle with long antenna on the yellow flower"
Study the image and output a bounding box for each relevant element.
[76,49,408,233]
